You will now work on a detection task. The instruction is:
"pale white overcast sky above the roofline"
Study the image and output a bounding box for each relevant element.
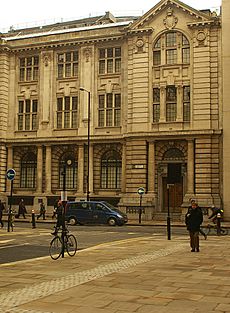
[0,0,223,31]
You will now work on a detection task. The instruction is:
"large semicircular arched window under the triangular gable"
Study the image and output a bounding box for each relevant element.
[153,31,190,66]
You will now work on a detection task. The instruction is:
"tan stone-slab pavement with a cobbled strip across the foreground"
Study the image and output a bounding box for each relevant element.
[0,219,230,313]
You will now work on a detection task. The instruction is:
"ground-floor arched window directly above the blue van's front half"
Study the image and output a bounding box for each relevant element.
[101,151,122,189]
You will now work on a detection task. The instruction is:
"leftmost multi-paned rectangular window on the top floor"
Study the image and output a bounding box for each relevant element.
[19,56,39,81]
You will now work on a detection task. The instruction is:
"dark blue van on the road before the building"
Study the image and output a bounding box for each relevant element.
[65,201,128,226]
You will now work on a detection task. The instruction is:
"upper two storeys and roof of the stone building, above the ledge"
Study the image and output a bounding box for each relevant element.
[0,0,222,141]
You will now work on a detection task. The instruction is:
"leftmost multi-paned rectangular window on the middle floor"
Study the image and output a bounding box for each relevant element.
[18,99,38,130]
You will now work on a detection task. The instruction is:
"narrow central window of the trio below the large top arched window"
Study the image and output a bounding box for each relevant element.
[166,86,177,122]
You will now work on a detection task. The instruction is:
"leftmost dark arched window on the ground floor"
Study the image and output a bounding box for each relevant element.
[20,152,37,188]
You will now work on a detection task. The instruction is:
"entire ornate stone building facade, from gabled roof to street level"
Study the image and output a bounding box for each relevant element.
[0,0,223,219]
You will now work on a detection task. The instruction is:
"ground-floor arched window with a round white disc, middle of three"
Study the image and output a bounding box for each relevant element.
[59,154,77,190]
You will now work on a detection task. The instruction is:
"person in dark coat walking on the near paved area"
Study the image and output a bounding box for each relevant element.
[185,201,203,252]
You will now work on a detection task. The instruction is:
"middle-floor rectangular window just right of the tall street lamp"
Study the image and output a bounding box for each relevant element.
[98,93,121,127]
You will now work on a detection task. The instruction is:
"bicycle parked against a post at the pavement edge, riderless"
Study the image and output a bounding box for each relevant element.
[49,228,77,260]
